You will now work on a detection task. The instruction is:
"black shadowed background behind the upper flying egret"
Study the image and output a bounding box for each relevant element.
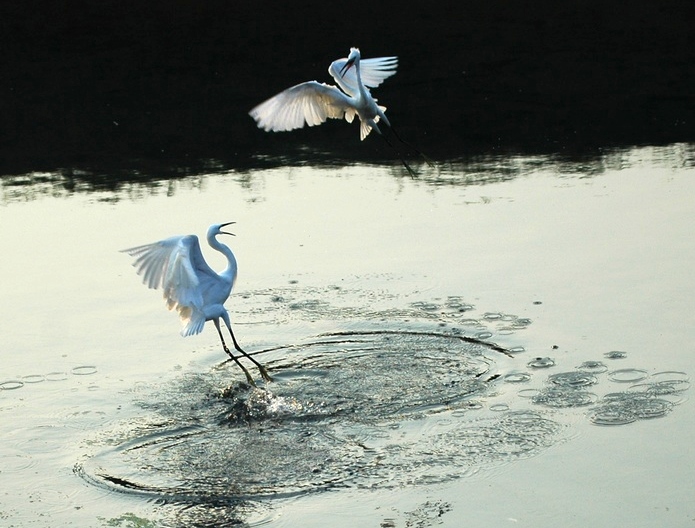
[0,0,695,174]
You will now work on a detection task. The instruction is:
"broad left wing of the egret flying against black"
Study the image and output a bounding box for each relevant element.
[249,81,355,132]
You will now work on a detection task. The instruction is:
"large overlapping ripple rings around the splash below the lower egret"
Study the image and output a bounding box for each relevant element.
[78,332,558,505]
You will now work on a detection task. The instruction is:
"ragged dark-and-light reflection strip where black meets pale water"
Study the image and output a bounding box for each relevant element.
[0,144,695,202]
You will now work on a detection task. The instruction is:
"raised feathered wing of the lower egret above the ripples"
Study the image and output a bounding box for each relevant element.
[123,235,217,336]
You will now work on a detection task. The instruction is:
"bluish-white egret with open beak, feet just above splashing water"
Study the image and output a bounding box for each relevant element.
[123,222,272,385]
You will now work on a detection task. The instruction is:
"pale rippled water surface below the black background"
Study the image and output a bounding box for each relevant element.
[0,145,695,527]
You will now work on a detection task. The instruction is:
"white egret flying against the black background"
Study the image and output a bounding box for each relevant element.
[249,48,420,175]
